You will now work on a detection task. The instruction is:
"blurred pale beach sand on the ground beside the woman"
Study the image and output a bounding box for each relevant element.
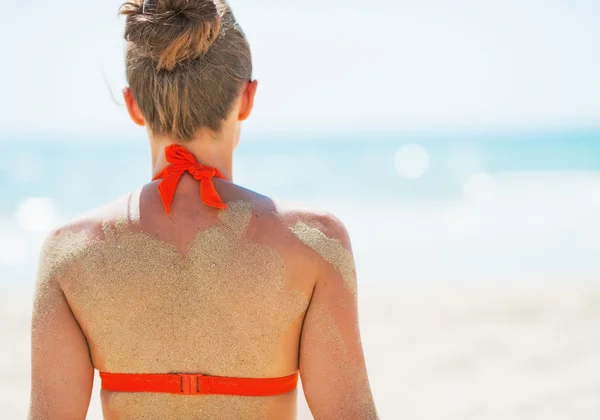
[0,284,600,420]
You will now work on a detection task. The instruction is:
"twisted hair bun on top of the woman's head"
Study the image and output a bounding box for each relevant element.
[120,0,221,70]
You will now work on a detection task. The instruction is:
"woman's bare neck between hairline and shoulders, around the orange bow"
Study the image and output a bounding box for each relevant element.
[150,129,233,181]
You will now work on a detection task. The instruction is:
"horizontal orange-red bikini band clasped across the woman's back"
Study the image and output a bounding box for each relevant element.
[100,372,298,397]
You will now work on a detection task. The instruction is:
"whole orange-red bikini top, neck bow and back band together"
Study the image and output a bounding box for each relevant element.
[100,144,298,397]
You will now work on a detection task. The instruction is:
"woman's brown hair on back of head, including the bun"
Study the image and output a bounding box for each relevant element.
[121,0,252,140]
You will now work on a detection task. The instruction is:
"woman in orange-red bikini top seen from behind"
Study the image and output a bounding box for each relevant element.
[30,0,377,420]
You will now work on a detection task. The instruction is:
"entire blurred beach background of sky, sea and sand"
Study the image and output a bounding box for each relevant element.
[0,0,600,420]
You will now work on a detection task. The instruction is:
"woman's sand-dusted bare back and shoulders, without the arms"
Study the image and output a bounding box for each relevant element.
[39,177,370,419]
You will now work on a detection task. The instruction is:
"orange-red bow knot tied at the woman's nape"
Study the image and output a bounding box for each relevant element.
[154,144,227,213]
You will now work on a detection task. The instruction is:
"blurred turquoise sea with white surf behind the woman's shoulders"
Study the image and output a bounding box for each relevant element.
[0,130,600,288]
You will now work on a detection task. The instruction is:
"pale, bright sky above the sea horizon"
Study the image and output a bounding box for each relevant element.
[0,0,600,139]
